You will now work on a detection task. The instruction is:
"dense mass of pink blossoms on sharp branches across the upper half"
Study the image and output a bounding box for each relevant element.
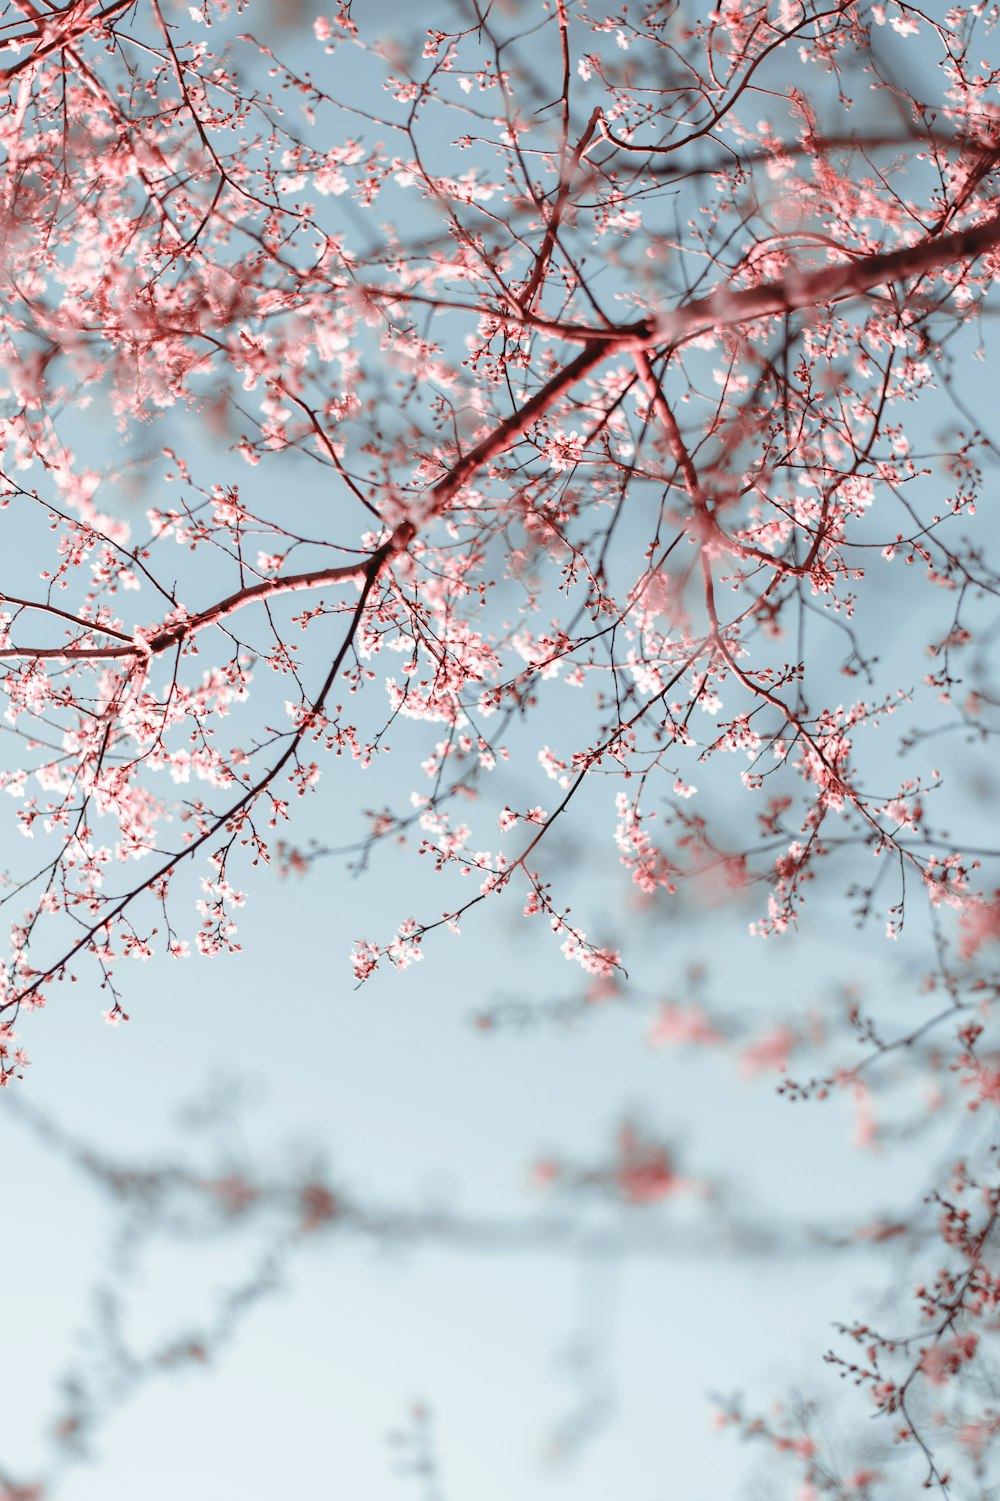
[2,0,1000,1016]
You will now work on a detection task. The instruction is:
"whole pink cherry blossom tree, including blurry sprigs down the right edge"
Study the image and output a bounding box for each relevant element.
[0,0,1000,1501]
